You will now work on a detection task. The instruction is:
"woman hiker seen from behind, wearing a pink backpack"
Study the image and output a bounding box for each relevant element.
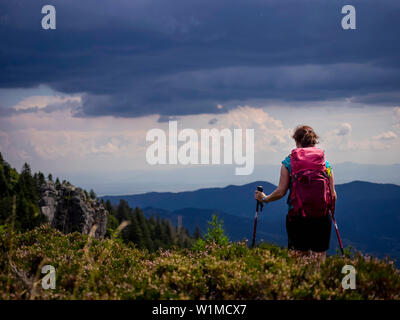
[255,126,337,258]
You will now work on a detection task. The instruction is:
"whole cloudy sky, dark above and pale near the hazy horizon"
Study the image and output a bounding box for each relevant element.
[0,0,400,191]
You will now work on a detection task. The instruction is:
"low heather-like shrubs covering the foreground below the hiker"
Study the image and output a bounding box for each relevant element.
[0,225,400,299]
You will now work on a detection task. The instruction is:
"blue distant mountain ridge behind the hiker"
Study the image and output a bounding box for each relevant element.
[103,181,400,259]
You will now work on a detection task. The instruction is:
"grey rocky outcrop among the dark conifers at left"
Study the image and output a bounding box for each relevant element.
[39,181,107,239]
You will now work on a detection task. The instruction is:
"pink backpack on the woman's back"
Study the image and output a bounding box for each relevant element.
[290,147,332,218]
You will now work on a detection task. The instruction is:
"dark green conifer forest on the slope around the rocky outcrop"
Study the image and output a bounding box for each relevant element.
[0,154,195,251]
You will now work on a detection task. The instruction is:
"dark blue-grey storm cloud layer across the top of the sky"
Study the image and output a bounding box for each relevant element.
[0,0,400,117]
